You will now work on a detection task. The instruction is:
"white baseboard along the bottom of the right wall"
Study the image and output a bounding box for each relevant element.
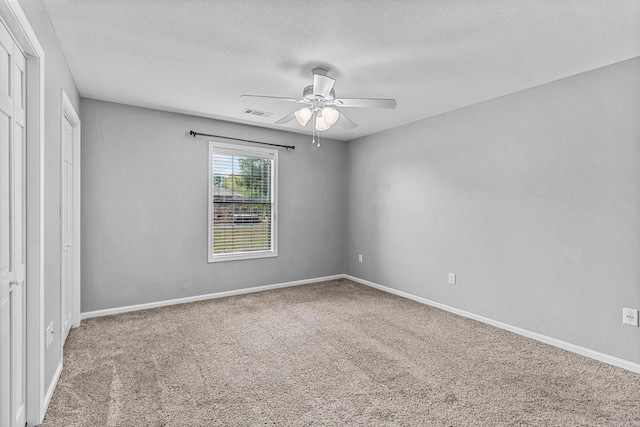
[343,274,640,373]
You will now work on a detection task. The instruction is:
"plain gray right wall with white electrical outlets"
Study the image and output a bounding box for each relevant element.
[345,58,640,363]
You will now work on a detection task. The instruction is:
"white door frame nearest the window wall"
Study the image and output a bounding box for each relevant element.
[60,89,81,342]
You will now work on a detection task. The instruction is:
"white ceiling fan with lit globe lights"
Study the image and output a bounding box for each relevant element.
[241,67,397,146]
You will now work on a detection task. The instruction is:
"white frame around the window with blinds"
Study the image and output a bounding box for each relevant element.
[207,140,278,262]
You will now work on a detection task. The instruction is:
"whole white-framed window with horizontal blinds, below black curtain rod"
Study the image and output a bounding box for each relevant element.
[209,141,278,262]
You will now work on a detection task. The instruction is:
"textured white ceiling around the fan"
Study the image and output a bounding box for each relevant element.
[44,0,640,140]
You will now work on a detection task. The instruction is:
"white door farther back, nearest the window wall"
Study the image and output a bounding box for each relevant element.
[60,115,75,343]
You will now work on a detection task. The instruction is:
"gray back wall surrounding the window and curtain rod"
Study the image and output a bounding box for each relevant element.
[81,99,346,312]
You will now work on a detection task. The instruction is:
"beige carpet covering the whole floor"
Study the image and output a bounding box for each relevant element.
[43,280,640,426]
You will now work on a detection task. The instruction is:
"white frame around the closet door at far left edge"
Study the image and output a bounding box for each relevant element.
[0,0,49,425]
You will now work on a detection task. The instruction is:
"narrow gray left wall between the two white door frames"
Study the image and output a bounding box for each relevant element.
[20,0,80,400]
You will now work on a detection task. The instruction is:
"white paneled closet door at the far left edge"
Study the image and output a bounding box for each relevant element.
[0,20,26,427]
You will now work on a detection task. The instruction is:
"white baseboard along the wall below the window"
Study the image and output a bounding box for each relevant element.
[80,274,345,320]
